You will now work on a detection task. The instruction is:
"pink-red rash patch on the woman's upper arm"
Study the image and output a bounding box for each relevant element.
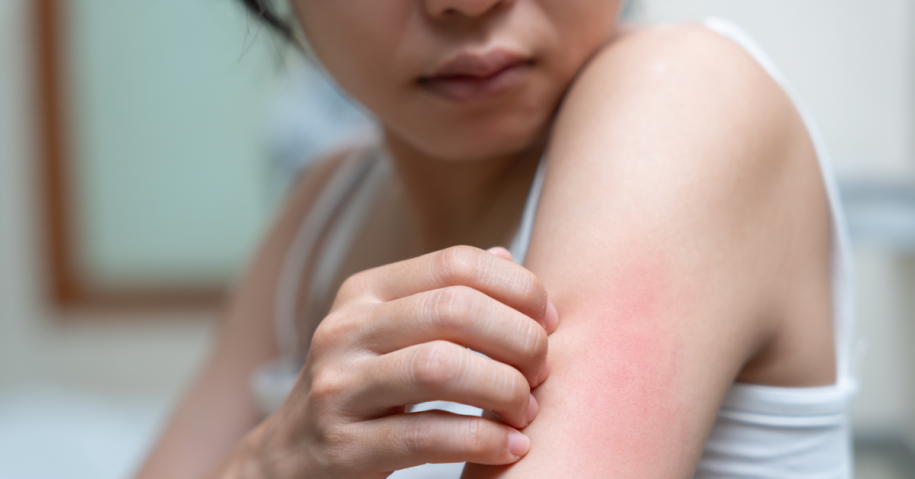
[544,258,683,468]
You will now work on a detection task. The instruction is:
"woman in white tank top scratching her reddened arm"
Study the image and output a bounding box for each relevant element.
[140,0,851,479]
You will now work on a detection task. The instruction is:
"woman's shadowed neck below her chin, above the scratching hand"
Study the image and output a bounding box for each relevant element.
[386,129,544,252]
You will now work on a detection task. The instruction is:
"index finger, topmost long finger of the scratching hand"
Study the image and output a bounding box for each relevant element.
[338,246,559,331]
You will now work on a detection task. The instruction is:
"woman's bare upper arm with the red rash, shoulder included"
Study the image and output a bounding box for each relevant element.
[465,26,818,478]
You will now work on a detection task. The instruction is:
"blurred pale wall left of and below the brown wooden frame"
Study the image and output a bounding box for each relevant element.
[0,0,214,401]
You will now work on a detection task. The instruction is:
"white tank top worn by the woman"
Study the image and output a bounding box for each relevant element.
[254,19,855,479]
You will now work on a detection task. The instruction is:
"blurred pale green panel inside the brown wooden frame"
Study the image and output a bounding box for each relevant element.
[68,0,288,283]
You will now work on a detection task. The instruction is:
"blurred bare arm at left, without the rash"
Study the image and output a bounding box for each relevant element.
[138,150,343,479]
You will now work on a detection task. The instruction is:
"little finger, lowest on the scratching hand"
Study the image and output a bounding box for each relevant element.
[359,411,530,471]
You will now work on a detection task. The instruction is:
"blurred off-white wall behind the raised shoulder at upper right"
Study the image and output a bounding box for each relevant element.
[635,0,915,181]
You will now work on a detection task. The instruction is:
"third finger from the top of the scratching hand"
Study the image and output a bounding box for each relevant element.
[353,341,538,428]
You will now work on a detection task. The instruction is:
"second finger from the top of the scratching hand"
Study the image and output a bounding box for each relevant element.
[360,286,548,388]
